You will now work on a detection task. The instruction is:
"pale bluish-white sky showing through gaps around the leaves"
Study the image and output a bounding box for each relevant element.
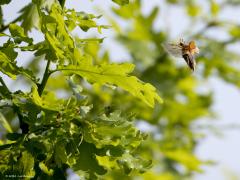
[0,0,240,180]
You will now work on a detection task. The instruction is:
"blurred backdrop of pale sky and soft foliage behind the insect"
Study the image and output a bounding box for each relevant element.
[1,0,240,180]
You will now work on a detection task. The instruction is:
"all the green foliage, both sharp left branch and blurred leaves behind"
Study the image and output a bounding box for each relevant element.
[0,0,240,179]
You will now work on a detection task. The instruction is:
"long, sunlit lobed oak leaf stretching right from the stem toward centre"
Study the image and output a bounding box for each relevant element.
[58,59,162,107]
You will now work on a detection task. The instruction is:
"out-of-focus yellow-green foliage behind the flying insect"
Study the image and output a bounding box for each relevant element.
[98,0,240,179]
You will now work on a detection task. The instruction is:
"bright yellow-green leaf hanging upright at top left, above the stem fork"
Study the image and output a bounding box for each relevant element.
[38,3,74,63]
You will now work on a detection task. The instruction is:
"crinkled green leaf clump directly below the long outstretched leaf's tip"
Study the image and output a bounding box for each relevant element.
[84,111,146,148]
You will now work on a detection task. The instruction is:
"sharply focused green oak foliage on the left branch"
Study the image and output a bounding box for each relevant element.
[0,1,161,179]
